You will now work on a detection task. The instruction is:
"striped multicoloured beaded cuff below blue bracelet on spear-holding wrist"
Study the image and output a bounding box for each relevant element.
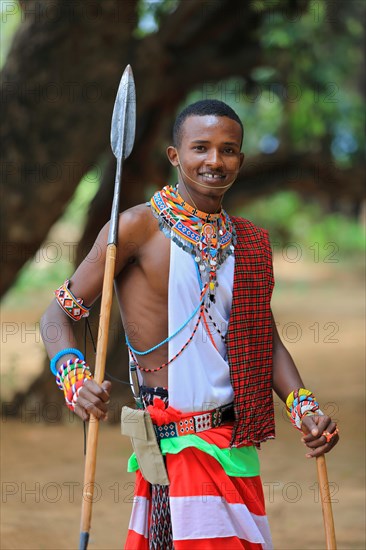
[56,357,93,411]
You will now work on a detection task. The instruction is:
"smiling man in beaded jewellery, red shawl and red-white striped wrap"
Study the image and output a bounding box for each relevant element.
[42,100,338,550]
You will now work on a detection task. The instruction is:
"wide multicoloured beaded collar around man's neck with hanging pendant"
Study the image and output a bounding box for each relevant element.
[148,185,236,302]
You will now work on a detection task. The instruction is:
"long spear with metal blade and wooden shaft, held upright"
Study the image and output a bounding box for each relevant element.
[79,65,136,550]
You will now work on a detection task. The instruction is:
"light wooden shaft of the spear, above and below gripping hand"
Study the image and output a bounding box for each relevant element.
[79,244,117,550]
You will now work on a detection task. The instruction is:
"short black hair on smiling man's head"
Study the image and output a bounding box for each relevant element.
[173,99,244,147]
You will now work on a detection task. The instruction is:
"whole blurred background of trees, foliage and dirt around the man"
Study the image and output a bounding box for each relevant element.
[0,0,366,550]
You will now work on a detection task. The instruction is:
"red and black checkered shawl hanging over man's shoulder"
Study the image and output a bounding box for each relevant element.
[226,217,275,447]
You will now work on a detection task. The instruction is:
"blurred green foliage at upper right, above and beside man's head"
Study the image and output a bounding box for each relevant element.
[179,0,365,168]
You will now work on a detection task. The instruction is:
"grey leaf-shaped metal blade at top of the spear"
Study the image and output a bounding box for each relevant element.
[111,65,136,161]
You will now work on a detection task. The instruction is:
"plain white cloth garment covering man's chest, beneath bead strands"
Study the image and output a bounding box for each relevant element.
[168,241,234,412]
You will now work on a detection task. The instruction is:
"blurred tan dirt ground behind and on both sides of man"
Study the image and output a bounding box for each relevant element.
[0,257,366,550]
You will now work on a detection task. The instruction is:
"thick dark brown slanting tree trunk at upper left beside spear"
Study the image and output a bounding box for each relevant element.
[1,0,137,298]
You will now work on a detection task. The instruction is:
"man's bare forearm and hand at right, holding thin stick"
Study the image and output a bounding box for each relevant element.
[272,315,339,458]
